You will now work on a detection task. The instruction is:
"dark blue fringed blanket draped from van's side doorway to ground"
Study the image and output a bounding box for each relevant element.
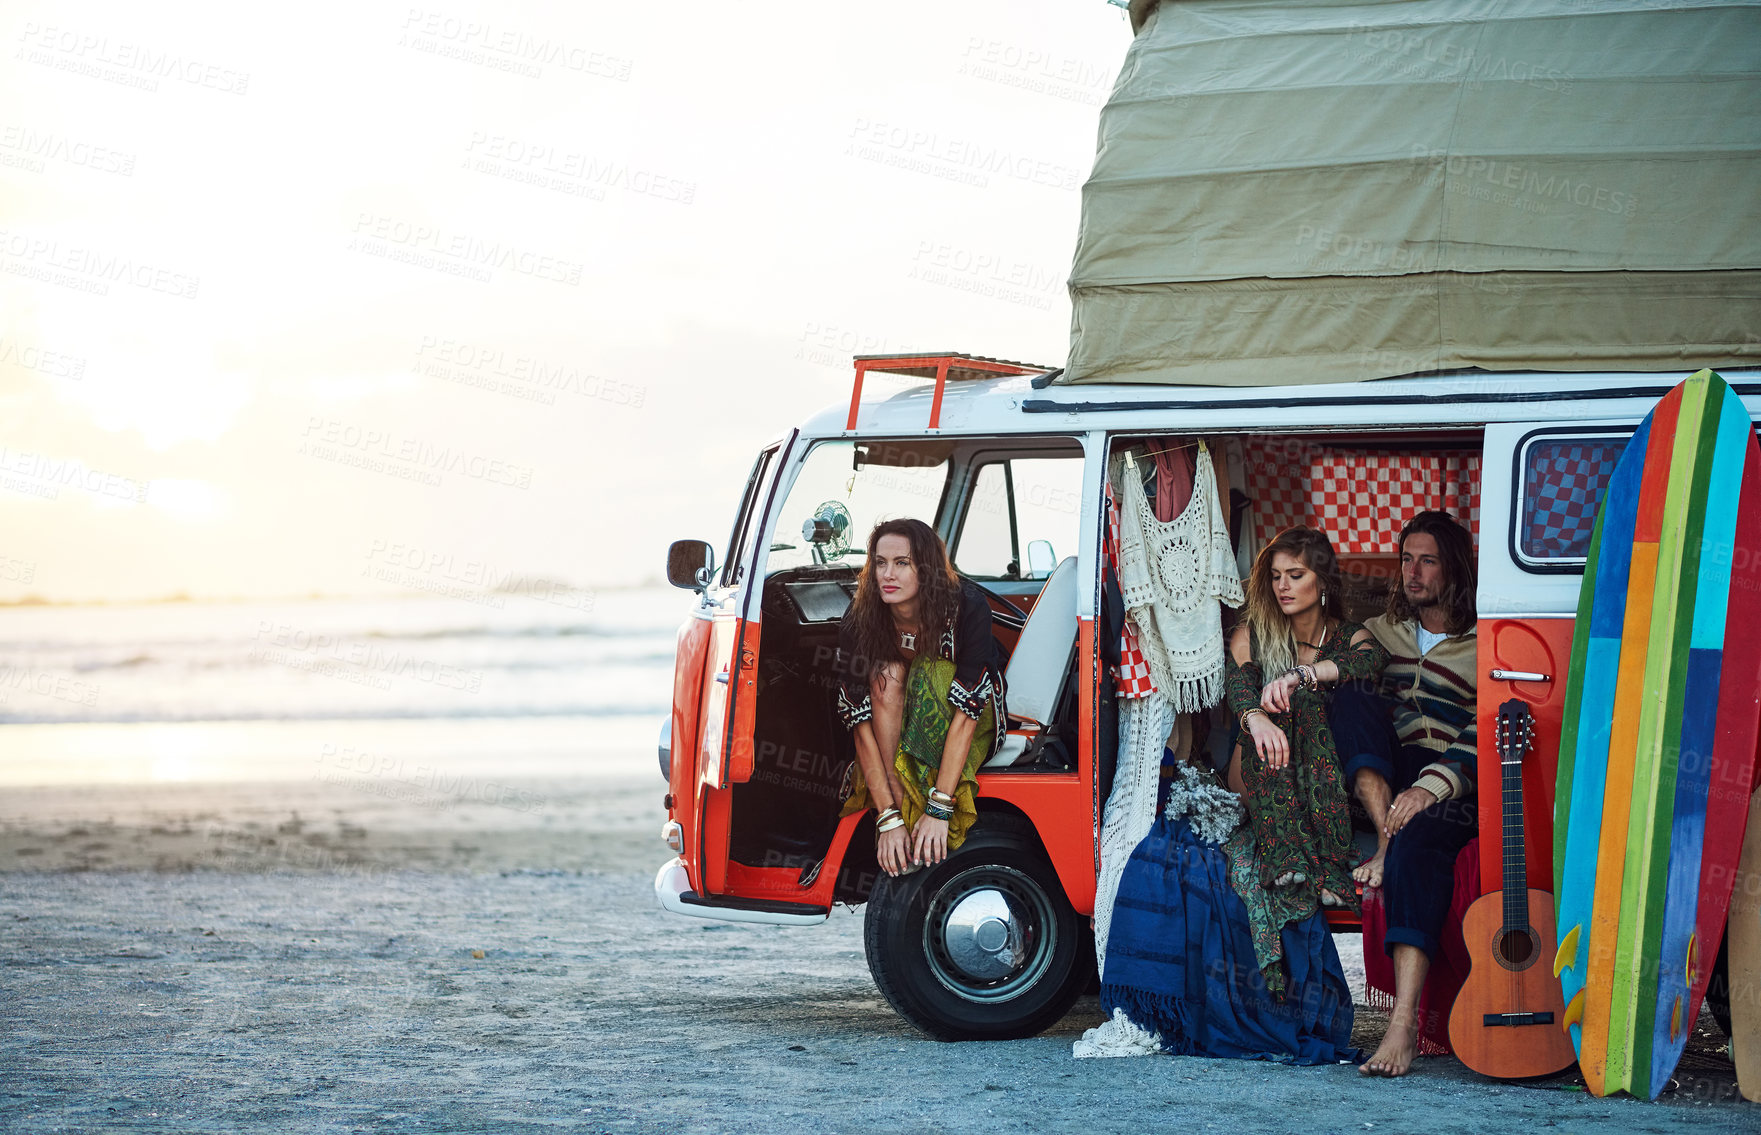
[1101,816,1361,1065]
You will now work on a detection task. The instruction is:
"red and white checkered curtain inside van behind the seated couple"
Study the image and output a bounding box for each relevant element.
[1243,438,1479,556]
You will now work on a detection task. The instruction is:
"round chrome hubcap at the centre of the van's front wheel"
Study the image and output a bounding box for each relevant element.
[923,866,1057,1001]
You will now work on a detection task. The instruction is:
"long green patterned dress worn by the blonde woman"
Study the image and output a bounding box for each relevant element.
[1224,623,1388,989]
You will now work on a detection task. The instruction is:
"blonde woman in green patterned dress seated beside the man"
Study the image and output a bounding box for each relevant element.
[1224,528,1388,987]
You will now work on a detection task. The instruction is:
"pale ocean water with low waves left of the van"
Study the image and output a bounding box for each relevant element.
[0,588,692,785]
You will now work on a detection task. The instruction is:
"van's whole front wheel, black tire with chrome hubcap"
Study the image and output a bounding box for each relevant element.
[863,813,1094,1040]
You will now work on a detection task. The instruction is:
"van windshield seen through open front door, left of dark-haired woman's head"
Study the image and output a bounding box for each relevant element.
[764,442,953,575]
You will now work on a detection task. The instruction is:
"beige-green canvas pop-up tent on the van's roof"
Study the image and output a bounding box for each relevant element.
[1057,0,1761,385]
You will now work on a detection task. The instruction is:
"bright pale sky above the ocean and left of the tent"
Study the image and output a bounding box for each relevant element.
[0,0,1131,600]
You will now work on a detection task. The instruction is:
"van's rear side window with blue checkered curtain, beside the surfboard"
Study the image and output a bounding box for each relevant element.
[1514,433,1632,567]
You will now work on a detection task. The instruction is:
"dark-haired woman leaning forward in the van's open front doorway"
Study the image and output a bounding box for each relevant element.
[836,519,1007,875]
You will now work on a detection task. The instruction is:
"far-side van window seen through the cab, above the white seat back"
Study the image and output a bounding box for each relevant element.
[953,450,1083,579]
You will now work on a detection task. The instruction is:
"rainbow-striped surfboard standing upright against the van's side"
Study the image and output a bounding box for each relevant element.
[1553,371,1761,1098]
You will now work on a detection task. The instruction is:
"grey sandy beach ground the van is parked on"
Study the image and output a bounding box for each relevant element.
[0,776,1757,1133]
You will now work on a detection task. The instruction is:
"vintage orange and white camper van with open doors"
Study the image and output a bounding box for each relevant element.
[655,354,1761,1038]
